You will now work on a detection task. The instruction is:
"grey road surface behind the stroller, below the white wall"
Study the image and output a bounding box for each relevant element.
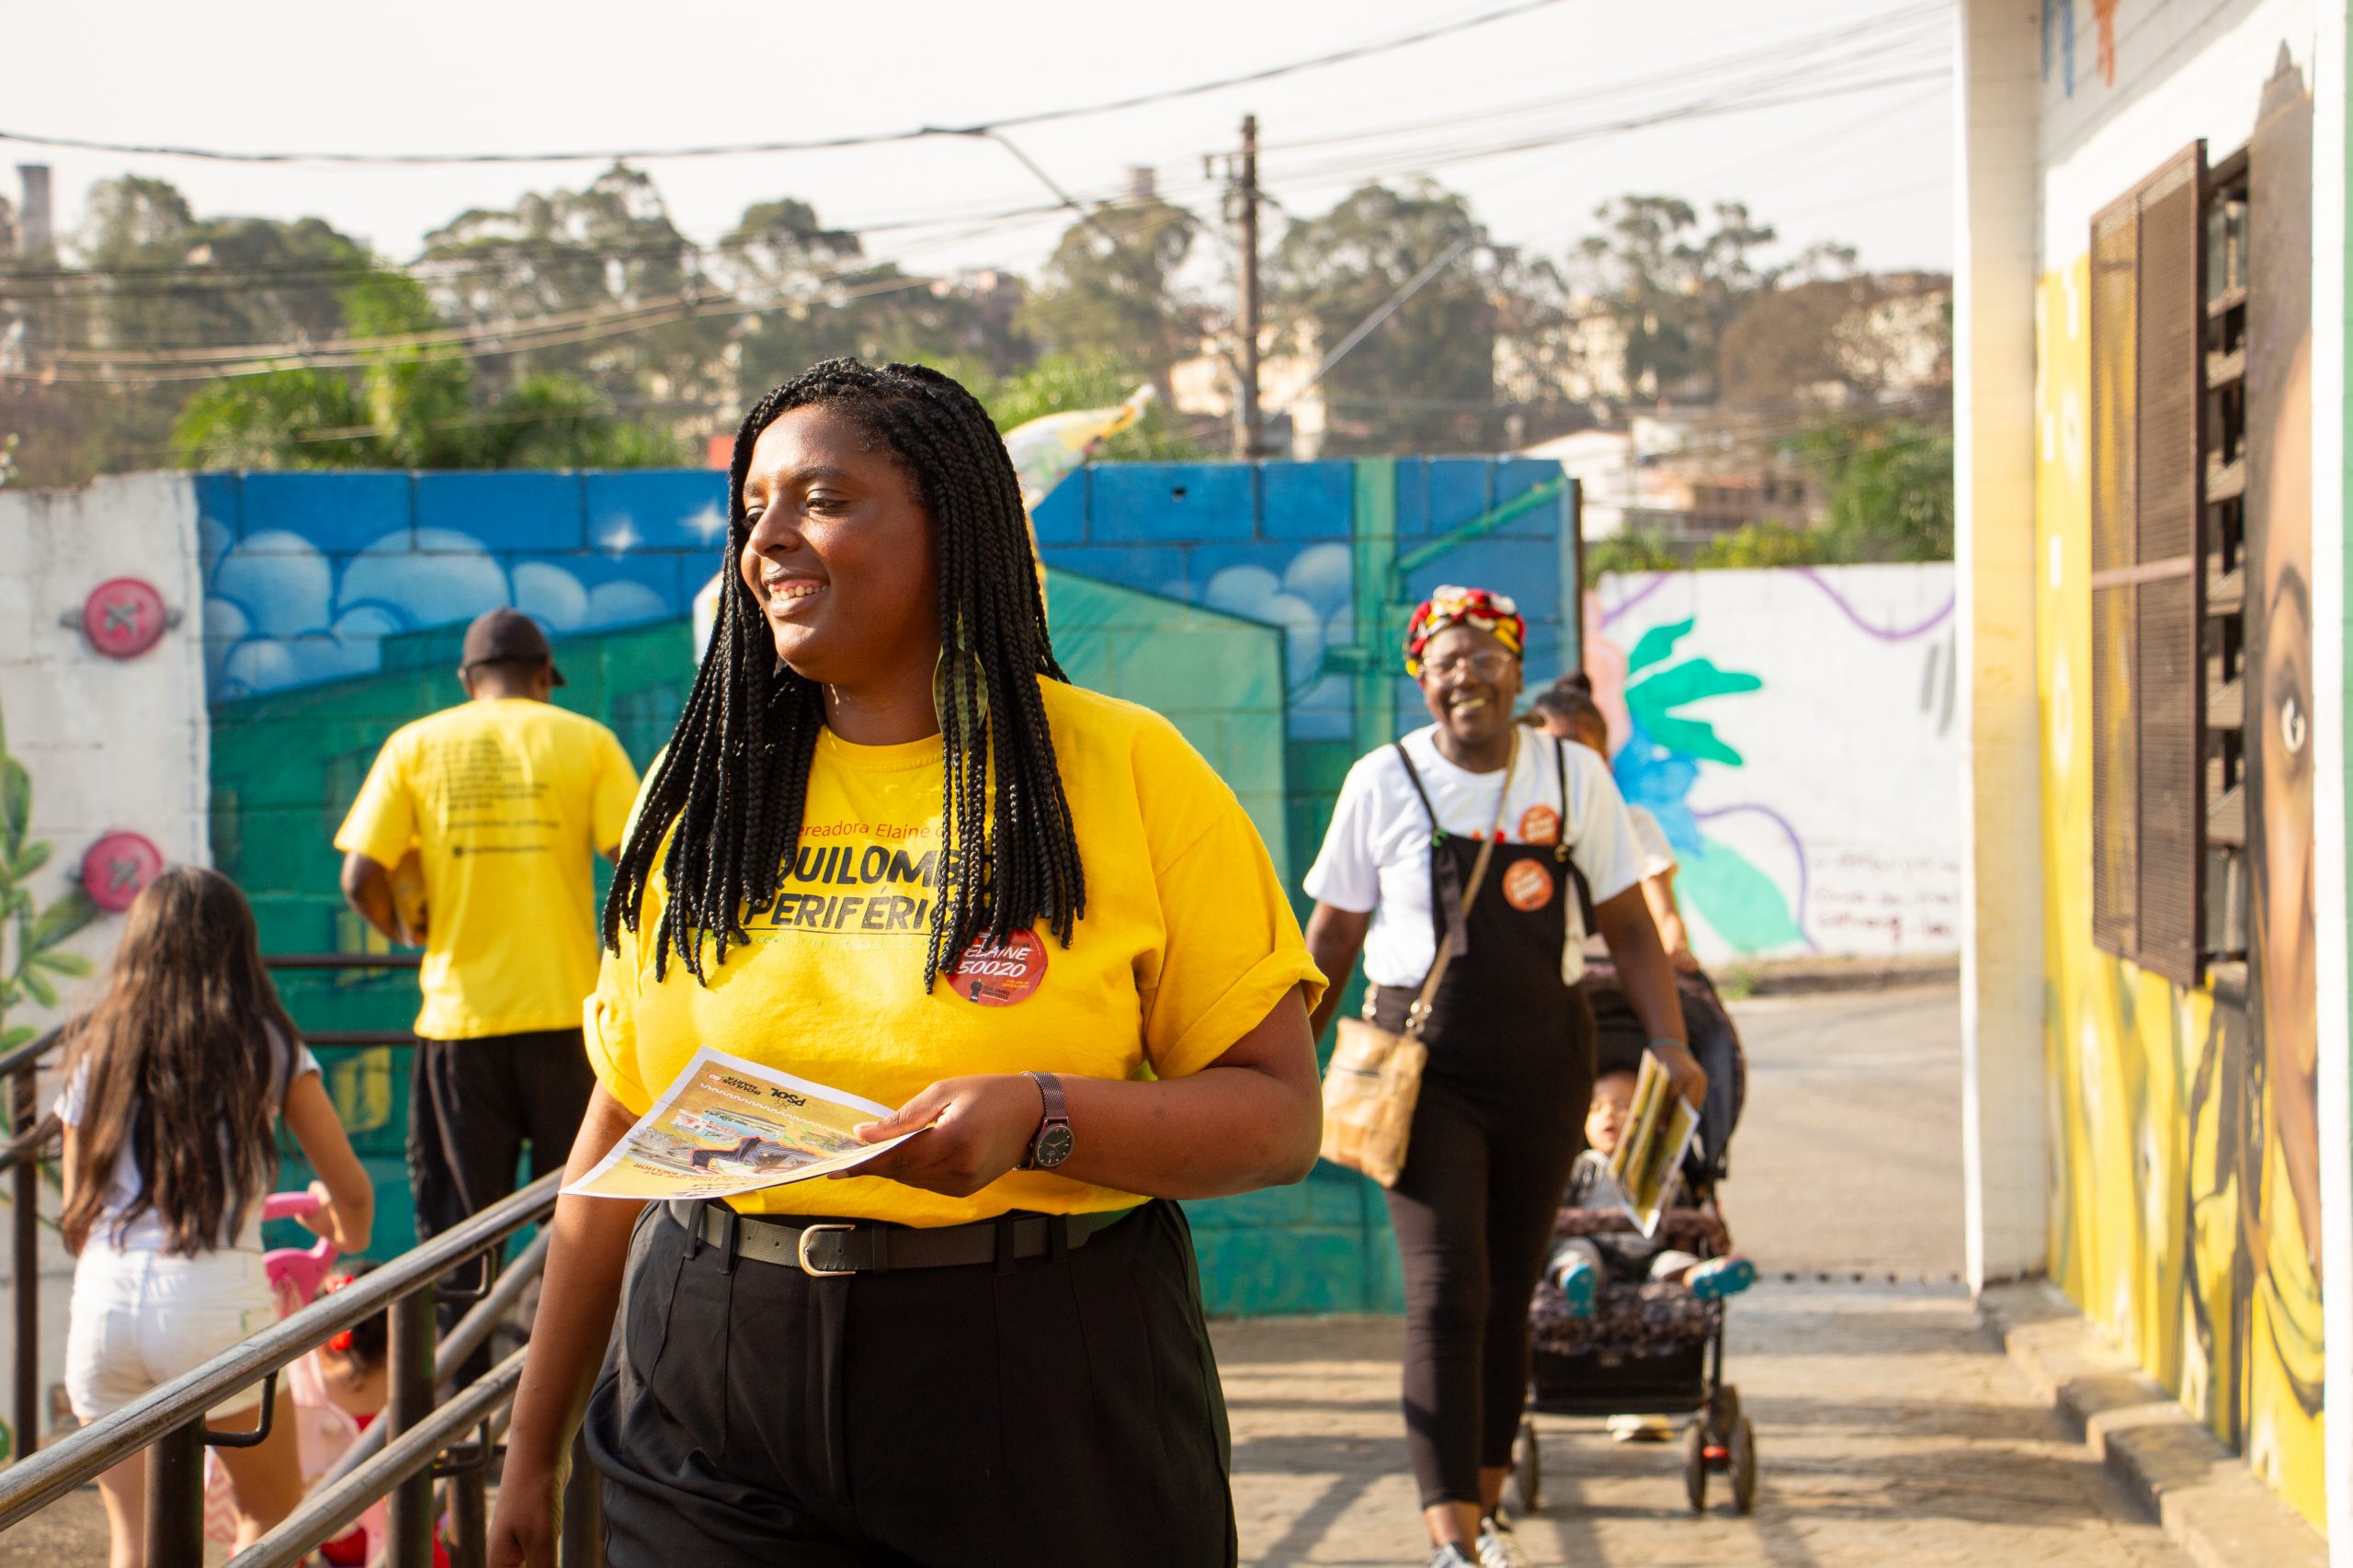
[1724,986,1962,1280]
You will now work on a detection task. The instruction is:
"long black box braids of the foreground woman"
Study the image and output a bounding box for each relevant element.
[605,360,1087,991]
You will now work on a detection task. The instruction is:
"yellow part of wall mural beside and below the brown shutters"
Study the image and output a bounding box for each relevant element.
[2035,259,2323,1528]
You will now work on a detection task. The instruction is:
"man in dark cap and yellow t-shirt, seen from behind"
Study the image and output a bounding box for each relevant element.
[335,609,638,1236]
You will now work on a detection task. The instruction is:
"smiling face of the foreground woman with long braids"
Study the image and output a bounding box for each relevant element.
[739,405,938,687]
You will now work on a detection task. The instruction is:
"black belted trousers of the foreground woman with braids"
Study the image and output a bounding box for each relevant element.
[585,1203,1238,1568]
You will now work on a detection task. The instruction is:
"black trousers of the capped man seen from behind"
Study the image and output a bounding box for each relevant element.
[409,1028,596,1238]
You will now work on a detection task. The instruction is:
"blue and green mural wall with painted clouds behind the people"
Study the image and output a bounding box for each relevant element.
[193,460,1576,1312]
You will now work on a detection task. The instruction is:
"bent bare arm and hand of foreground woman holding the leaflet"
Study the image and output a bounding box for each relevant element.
[852,986,1323,1199]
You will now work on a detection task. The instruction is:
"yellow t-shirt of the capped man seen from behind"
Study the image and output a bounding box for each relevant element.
[335,697,638,1040]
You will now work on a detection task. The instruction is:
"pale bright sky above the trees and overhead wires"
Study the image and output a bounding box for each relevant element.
[0,0,1953,283]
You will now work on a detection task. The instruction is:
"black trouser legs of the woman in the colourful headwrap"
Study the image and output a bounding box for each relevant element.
[1388,1001,1593,1509]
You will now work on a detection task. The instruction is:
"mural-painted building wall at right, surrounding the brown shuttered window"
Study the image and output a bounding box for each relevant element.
[2035,0,2344,1526]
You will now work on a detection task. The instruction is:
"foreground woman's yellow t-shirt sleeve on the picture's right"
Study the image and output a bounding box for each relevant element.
[1136,725,1324,1078]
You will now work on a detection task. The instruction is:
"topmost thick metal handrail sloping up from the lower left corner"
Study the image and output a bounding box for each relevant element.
[0,1173,563,1530]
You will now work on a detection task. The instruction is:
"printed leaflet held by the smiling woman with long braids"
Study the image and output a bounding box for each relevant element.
[564,1045,920,1200]
